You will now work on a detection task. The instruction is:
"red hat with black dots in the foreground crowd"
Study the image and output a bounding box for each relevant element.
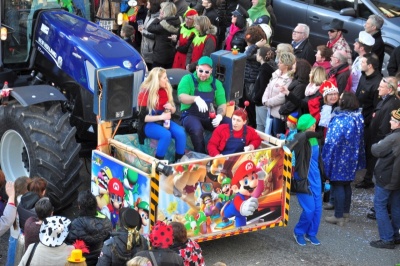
[149,221,174,248]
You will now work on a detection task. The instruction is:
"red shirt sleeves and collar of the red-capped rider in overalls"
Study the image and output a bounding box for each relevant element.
[207,124,261,156]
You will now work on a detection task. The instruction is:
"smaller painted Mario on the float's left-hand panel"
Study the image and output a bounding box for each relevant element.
[107,178,124,229]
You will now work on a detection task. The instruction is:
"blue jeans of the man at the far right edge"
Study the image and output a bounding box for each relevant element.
[374,186,400,241]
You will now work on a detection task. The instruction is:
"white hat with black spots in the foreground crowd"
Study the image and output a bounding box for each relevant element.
[39,216,71,247]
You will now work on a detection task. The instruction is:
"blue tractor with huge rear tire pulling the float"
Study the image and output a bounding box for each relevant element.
[0,0,146,210]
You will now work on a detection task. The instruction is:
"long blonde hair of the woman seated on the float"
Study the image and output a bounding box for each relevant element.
[140,67,175,113]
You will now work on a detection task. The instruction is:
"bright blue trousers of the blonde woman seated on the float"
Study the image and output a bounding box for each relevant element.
[144,121,186,158]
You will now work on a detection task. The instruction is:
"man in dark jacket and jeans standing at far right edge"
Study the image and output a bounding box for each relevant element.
[370,109,400,249]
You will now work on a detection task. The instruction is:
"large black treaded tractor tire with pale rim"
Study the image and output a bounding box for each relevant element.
[0,101,82,211]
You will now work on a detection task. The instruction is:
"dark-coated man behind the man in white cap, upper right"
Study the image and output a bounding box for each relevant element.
[364,15,385,71]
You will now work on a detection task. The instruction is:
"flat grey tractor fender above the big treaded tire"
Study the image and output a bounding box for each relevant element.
[10,85,67,107]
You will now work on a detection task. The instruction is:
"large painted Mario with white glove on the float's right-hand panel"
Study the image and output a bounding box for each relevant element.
[216,160,265,228]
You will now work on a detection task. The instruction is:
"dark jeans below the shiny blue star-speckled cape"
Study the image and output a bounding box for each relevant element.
[331,182,352,218]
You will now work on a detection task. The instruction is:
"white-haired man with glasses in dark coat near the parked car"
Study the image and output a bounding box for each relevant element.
[292,23,315,65]
